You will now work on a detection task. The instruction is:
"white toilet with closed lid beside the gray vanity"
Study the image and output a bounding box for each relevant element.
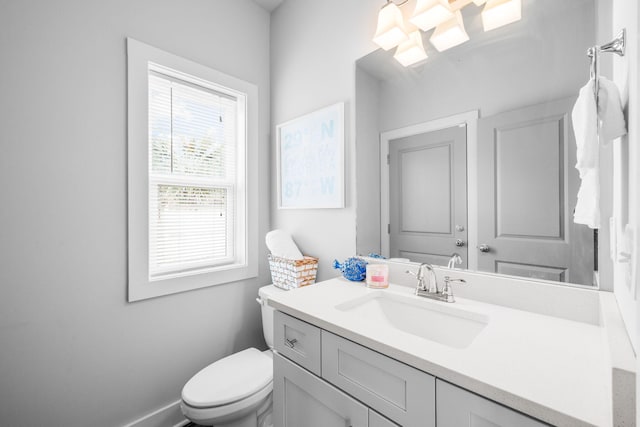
[180,285,285,427]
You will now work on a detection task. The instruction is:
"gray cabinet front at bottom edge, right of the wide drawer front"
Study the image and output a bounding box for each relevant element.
[436,380,547,427]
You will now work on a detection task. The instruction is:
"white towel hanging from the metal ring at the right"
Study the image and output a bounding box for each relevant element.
[571,77,627,229]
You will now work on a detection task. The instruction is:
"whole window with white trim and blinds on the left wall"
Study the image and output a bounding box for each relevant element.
[127,39,257,301]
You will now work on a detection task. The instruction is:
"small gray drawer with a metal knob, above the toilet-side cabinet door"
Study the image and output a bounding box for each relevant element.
[273,311,320,376]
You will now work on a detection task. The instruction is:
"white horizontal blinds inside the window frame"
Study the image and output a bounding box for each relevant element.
[148,70,243,280]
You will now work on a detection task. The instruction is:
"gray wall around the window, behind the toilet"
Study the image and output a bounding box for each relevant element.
[0,0,270,427]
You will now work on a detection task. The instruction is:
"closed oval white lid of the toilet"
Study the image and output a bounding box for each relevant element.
[182,348,273,408]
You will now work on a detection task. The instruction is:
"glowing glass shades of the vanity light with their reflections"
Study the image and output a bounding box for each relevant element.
[373,0,522,67]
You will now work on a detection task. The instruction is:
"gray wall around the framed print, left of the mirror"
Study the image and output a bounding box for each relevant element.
[271,0,381,280]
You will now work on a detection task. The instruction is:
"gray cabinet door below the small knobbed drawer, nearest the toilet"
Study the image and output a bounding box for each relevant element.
[273,354,369,427]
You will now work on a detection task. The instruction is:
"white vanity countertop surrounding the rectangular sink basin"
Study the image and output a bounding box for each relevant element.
[268,278,624,427]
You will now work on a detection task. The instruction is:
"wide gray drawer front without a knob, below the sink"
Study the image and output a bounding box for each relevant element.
[322,331,436,427]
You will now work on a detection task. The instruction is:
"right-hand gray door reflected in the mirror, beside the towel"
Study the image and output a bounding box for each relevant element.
[478,98,594,285]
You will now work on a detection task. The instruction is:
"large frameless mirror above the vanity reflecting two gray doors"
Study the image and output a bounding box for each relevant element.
[356,0,611,286]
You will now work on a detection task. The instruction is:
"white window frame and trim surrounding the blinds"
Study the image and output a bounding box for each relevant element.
[127,38,258,302]
